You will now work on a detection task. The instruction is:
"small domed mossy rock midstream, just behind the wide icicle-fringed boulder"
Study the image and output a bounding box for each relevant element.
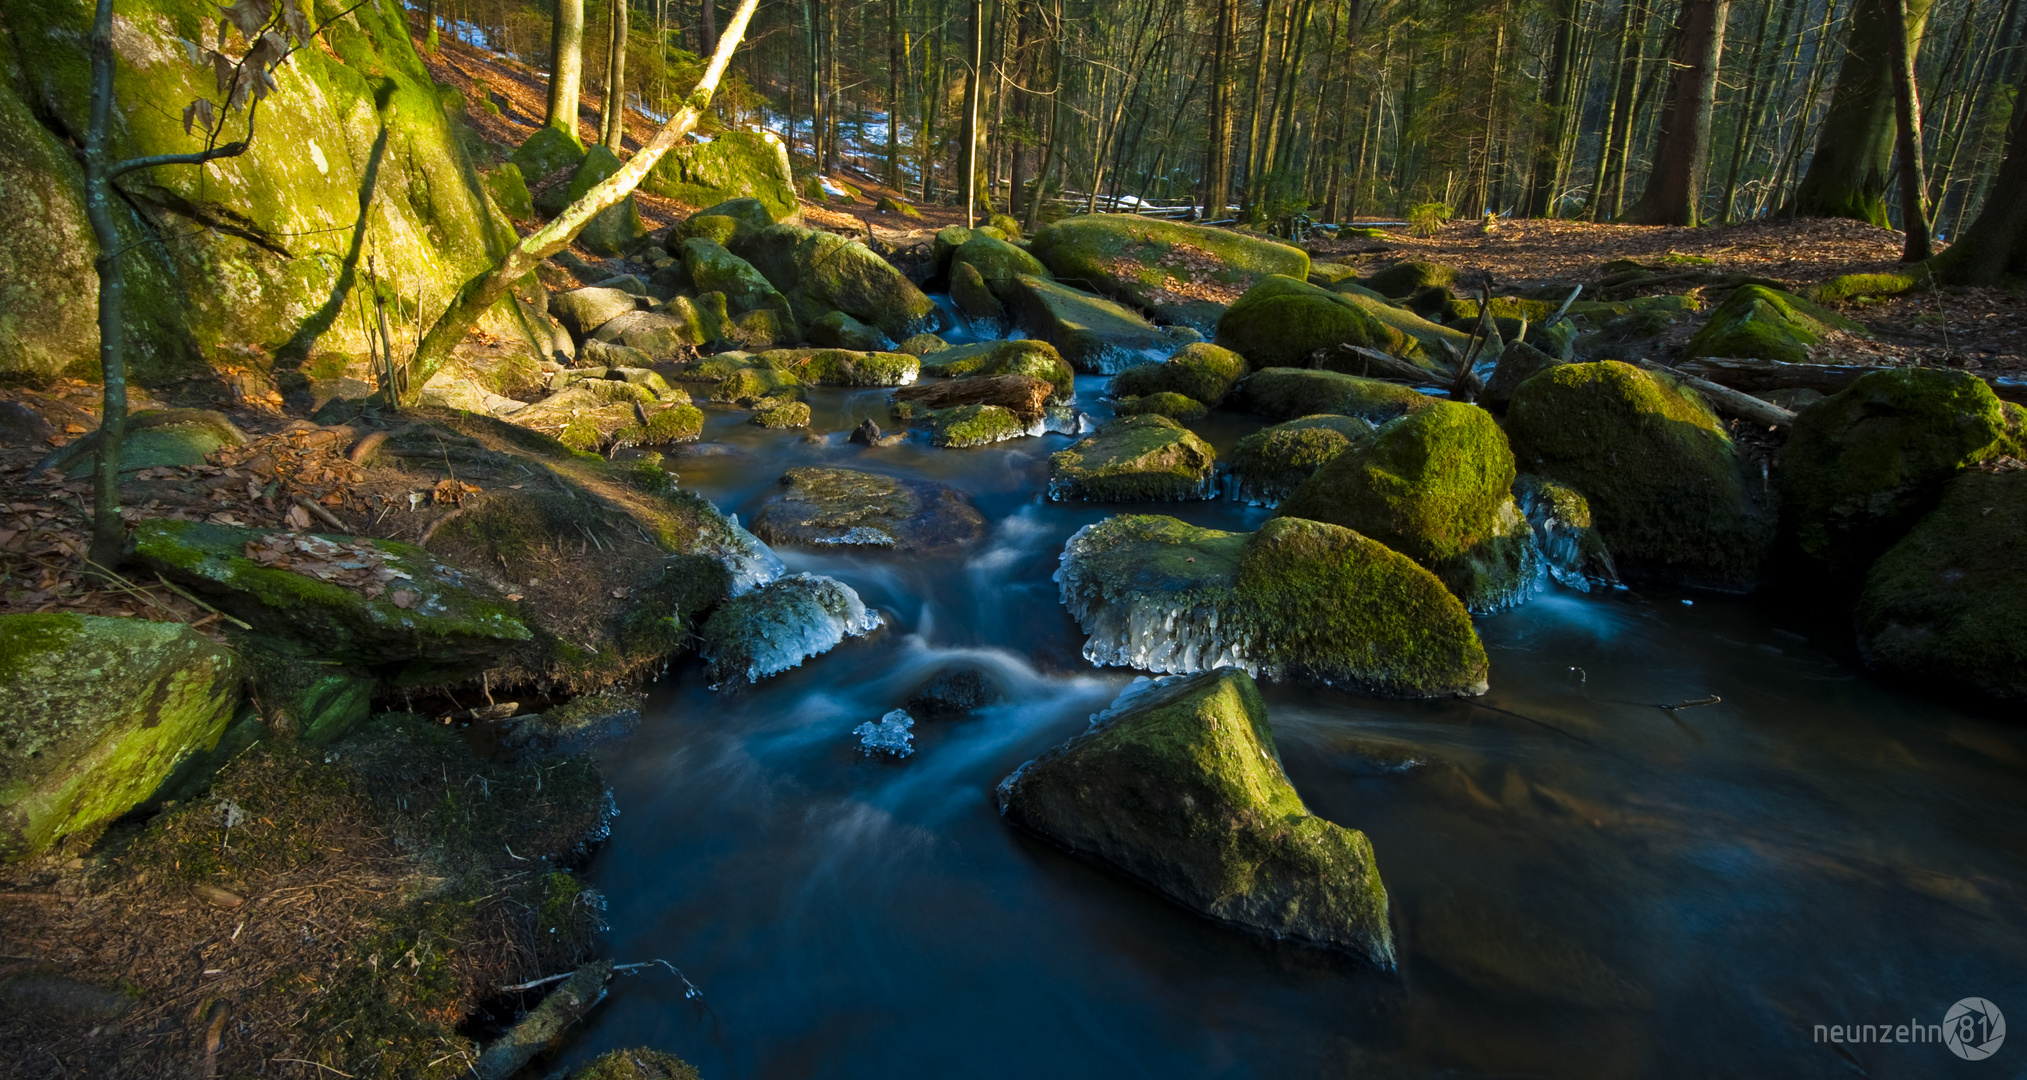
[1048,415,1216,503]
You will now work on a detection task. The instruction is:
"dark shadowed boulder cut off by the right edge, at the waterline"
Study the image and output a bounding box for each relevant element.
[1857,468,2027,703]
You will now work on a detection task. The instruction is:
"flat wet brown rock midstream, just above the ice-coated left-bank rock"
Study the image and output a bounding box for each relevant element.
[752,468,985,551]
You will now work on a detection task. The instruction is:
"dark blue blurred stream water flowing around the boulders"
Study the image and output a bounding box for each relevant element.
[566,332,2027,1080]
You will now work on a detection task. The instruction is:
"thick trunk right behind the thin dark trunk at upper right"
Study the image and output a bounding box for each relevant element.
[1790,0,1934,227]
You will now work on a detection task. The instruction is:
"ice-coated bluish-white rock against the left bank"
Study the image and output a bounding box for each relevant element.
[701,573,880,687]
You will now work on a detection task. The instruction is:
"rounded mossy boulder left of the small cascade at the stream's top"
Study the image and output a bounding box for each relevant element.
[732,225,936,340]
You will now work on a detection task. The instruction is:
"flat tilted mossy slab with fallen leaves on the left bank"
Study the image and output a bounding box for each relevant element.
[134,519,533,685]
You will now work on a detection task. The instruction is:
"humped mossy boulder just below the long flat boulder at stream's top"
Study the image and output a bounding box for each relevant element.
[1216,278,1433,372]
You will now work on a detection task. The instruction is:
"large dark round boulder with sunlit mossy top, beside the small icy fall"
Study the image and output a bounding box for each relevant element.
[1506,361,1772,592]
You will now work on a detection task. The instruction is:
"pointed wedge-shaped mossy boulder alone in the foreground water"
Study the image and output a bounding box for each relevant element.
[995,669,1395,969]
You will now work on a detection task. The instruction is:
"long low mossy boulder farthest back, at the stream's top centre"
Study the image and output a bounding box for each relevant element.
[1028,215,1309,310]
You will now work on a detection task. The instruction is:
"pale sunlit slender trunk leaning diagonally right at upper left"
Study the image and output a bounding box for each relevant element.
[401,0,760,405]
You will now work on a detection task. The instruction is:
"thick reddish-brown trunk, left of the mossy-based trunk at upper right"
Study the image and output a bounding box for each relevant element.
[1626,0,1731,225]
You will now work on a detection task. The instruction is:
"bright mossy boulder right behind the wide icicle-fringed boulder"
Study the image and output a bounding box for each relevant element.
[1281,401,1534,612]
